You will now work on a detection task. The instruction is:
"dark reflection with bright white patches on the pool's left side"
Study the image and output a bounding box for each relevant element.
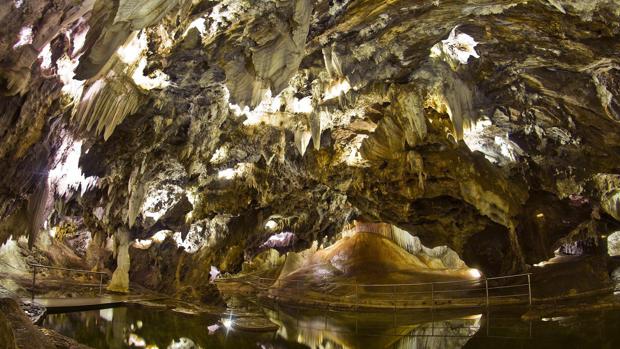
[43,305,274,349]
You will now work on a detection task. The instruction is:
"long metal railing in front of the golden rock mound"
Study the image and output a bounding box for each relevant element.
[239,273,532,310]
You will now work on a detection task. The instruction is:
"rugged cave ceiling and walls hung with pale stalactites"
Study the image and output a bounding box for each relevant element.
[0,0,620,271]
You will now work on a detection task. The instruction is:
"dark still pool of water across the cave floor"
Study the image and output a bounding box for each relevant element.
[43,305,620,349]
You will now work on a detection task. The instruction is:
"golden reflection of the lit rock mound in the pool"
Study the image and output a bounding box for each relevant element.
[266,309,482,348]
